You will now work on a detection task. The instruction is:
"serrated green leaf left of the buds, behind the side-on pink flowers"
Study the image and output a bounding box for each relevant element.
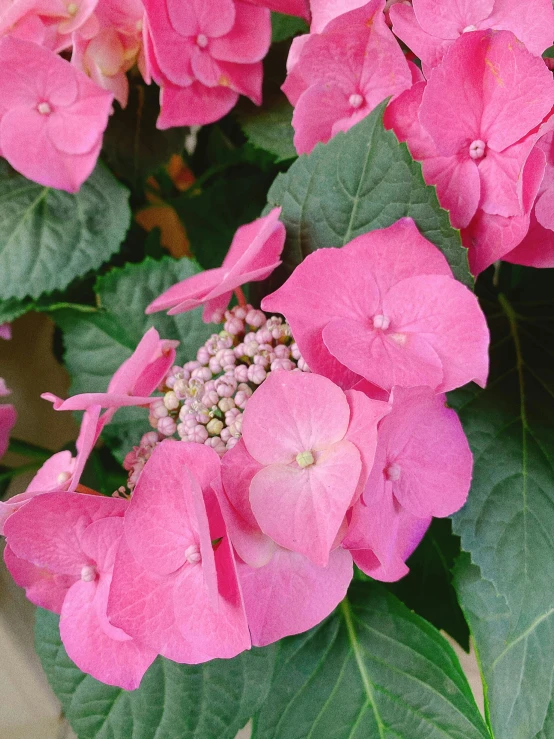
[53,257,213,460]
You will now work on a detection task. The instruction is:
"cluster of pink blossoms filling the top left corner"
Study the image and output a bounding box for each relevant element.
[0,0,308,192]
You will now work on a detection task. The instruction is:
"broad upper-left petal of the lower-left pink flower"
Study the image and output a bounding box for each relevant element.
[4,492,127,577]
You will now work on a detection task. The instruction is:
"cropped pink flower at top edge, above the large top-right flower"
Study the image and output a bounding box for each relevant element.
[390,0,554,72]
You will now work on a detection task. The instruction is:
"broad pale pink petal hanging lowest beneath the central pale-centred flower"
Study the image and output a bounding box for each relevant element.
[239,549,352,647]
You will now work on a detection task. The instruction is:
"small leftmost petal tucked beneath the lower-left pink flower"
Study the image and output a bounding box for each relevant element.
[4,546,75,613]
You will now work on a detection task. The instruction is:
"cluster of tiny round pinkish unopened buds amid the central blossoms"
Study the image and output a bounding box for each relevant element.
[125,305,309,490]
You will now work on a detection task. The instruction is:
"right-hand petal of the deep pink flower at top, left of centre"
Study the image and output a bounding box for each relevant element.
[210,0,271,64]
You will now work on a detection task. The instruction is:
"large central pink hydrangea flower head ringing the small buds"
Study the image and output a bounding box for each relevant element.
[0,207,489,689]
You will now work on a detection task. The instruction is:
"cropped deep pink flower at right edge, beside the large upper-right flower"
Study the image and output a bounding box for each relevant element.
[503,133,554,267]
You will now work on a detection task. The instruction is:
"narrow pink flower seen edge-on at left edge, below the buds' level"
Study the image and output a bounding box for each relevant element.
[0,406,101,535]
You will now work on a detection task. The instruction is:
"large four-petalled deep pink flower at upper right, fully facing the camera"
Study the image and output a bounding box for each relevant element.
[385,31,554,273]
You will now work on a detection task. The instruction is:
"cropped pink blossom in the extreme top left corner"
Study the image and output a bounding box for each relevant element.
[0,0,98,53]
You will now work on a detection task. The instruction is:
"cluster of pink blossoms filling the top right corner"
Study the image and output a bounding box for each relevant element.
[283,0,554,274]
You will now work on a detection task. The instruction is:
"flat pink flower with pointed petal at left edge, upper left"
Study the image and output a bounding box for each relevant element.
[0,37,113,192]
